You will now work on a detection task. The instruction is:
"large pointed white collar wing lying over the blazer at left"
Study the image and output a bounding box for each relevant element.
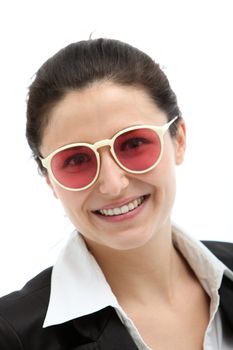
[43,231,118,327]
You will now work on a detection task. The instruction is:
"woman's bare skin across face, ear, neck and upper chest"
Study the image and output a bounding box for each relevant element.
[41,82,208,350]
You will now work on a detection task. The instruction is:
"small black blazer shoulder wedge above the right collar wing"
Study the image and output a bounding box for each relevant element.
[202,241,233,270]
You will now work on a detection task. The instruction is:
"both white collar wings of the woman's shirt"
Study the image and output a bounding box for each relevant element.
[43,227,230,327]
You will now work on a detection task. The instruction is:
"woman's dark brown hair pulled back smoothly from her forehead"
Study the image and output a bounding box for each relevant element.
[26,38,181,173]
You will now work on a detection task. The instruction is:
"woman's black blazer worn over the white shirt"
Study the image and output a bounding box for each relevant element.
[0,241,233,350]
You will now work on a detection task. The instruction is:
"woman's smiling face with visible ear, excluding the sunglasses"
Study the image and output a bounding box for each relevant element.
[41,82,185,250]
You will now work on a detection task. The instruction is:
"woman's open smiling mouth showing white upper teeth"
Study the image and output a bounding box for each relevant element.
[95,195,149,216]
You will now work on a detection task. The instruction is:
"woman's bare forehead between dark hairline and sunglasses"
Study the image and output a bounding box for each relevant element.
[41,82,166,154]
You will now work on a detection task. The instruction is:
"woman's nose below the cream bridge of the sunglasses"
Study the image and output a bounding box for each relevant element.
[98,148,129,197]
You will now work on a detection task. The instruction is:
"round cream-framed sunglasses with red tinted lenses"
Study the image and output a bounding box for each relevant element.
[40,117,178,191]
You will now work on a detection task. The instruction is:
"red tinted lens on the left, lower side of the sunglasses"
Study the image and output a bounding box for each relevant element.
[51,146,97,189]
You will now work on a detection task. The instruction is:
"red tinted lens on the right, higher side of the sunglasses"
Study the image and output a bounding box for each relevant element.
[114,128,161,171]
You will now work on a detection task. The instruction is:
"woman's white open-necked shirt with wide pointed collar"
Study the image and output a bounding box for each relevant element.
[43,227,233,350]
